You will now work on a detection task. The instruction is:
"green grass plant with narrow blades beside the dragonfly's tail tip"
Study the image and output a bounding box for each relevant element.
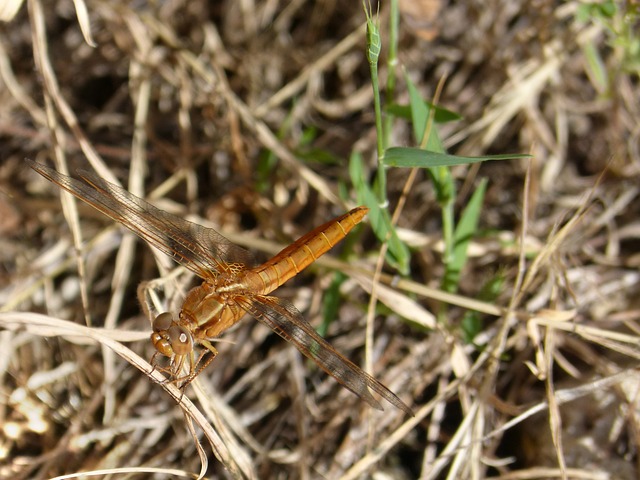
[356,1,528,308]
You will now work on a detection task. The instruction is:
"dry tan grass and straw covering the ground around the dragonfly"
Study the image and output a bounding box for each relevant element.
[0,0,640,479]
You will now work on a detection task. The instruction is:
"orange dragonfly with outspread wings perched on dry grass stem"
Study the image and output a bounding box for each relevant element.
[26,160,413,415]
